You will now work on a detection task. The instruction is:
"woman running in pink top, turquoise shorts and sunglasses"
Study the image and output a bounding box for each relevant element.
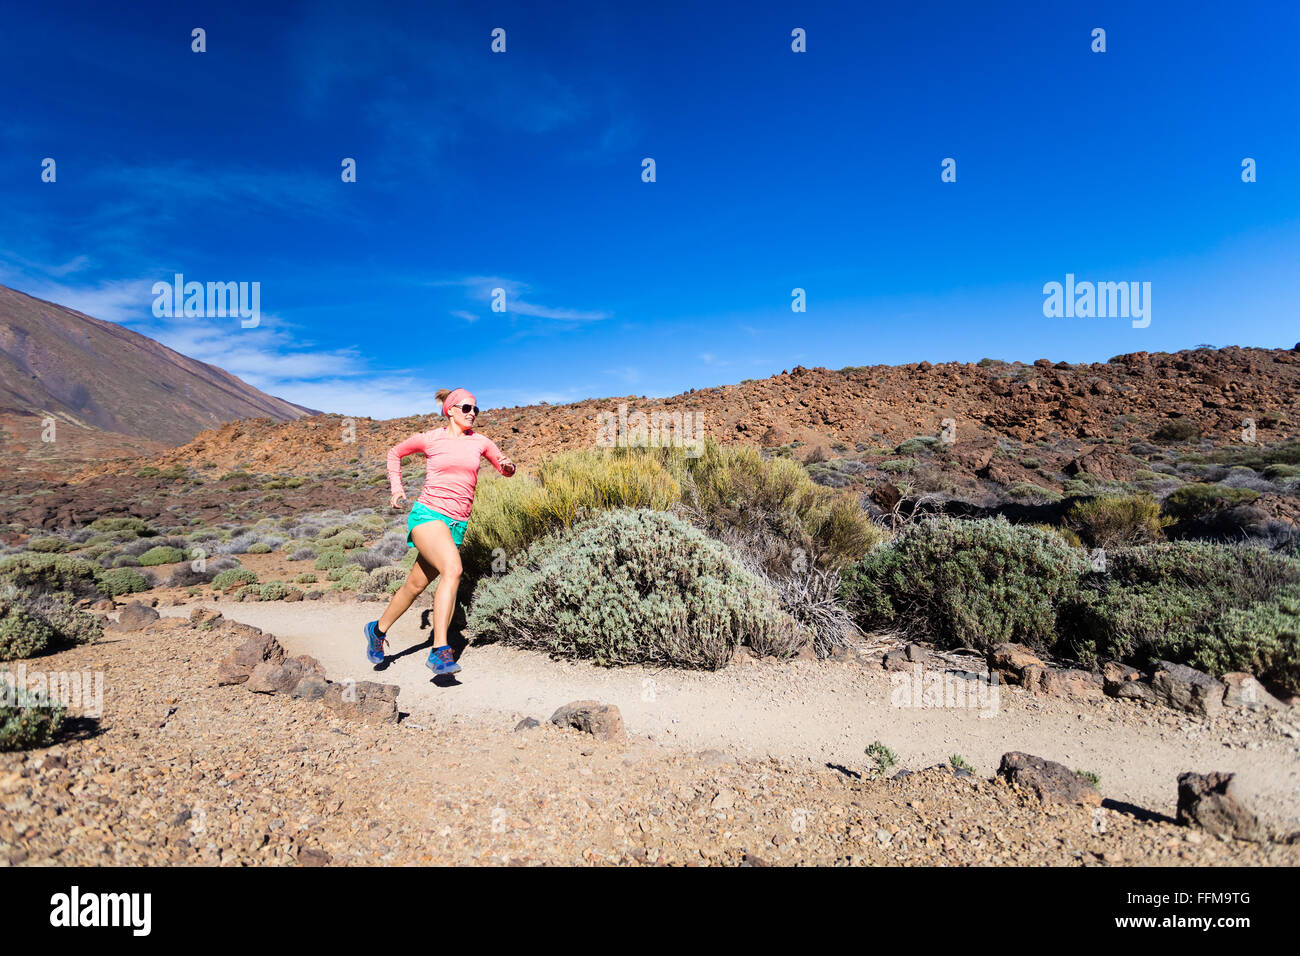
[365,389,515,675]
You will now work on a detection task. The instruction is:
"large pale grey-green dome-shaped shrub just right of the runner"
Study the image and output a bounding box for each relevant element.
[468,509,809,669]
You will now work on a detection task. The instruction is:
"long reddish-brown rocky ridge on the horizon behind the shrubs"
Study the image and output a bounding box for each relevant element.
[74,346,1300,481]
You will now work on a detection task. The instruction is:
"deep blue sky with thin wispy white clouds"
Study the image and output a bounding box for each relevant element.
[0,0,1300,418]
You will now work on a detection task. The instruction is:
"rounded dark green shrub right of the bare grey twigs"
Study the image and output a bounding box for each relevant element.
[840,516,1088,650]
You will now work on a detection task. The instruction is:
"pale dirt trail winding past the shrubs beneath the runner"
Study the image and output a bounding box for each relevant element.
[157,601,1300,831]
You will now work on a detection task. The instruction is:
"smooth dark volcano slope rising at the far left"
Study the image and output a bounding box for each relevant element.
[0,286,315,473]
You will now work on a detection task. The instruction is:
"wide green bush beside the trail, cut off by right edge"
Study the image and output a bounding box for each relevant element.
[1065,541,1300,693]
